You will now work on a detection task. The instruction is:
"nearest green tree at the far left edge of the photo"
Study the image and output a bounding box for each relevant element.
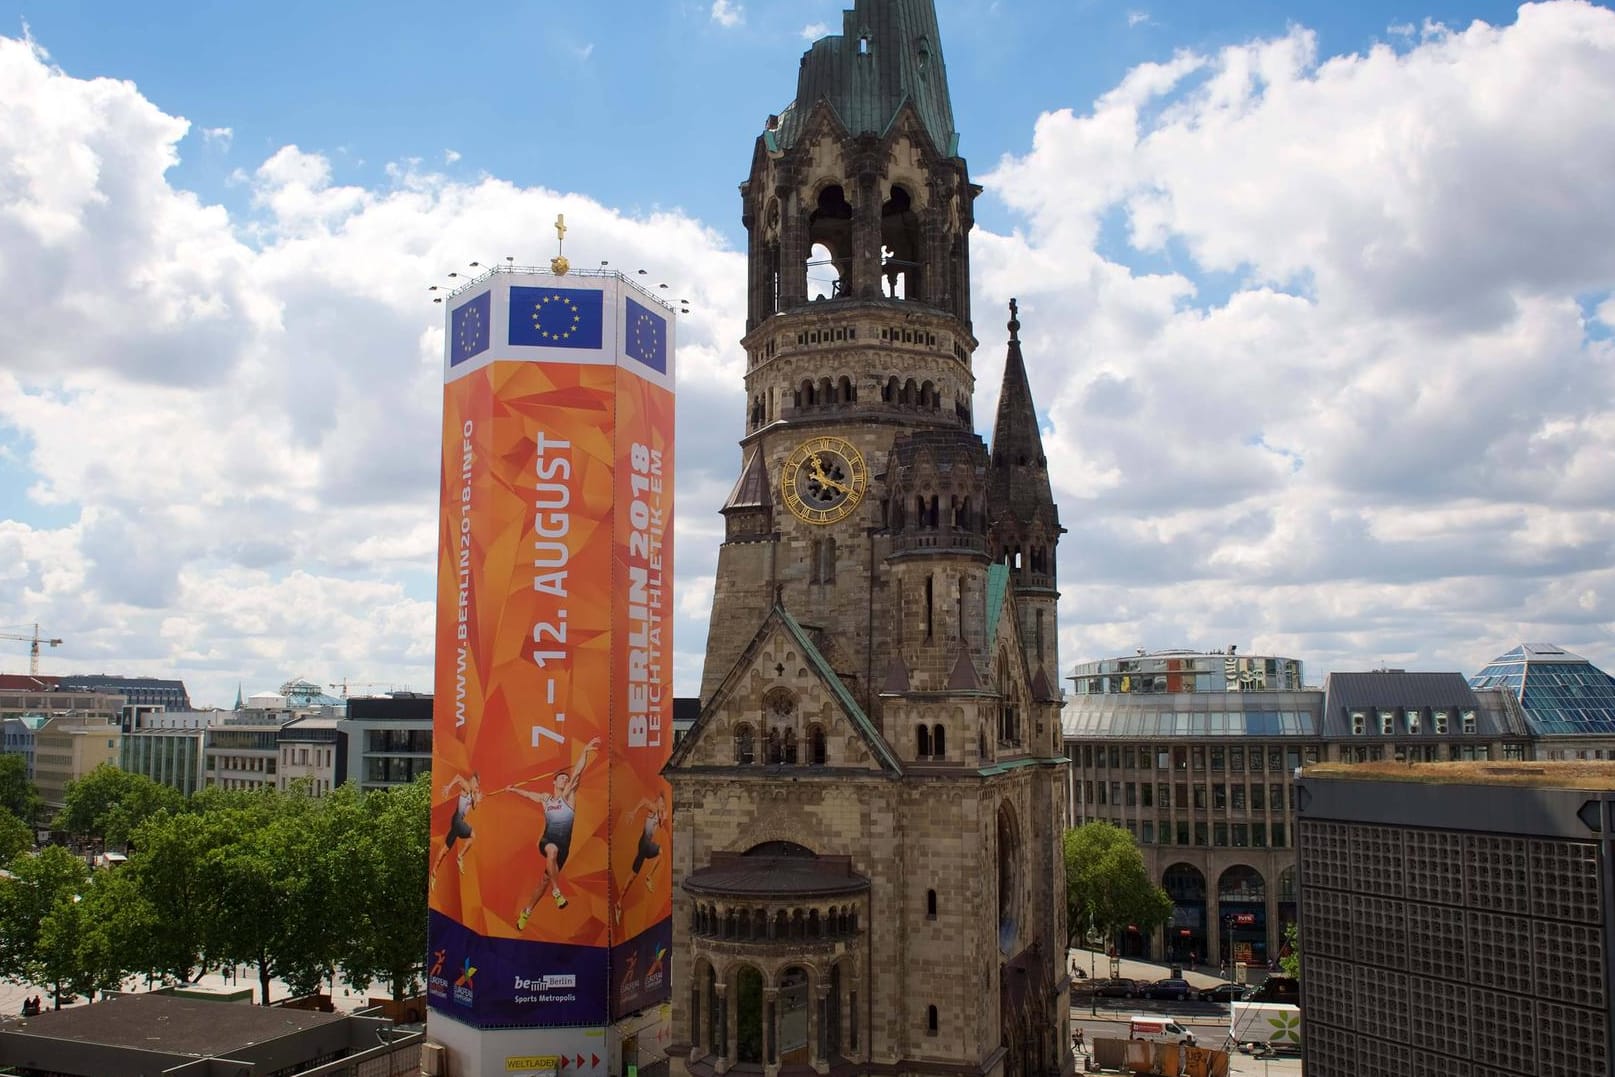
[0,844,89,1009]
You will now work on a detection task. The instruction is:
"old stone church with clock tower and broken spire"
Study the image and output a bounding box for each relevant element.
[667,0,1071,1077]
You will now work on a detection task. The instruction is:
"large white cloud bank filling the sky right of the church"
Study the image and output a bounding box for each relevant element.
[975,3,1615,672]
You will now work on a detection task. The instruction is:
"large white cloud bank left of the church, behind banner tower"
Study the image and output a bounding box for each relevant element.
[0,39,743,704]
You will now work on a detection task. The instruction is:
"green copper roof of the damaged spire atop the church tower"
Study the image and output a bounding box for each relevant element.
[764,0,959,157]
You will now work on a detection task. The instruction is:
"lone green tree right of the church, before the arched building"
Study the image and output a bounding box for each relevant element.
[1064,822,1172,941]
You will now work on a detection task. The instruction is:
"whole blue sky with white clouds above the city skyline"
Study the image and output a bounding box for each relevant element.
[0,0,1615,706]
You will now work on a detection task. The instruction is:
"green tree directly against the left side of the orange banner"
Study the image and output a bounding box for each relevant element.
[333,775,431,1001]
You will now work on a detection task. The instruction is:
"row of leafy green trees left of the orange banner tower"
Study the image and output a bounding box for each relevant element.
[0,757,431,1008]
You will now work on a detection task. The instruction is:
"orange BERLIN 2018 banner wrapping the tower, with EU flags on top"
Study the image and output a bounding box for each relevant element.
[428,269,673,1027]
